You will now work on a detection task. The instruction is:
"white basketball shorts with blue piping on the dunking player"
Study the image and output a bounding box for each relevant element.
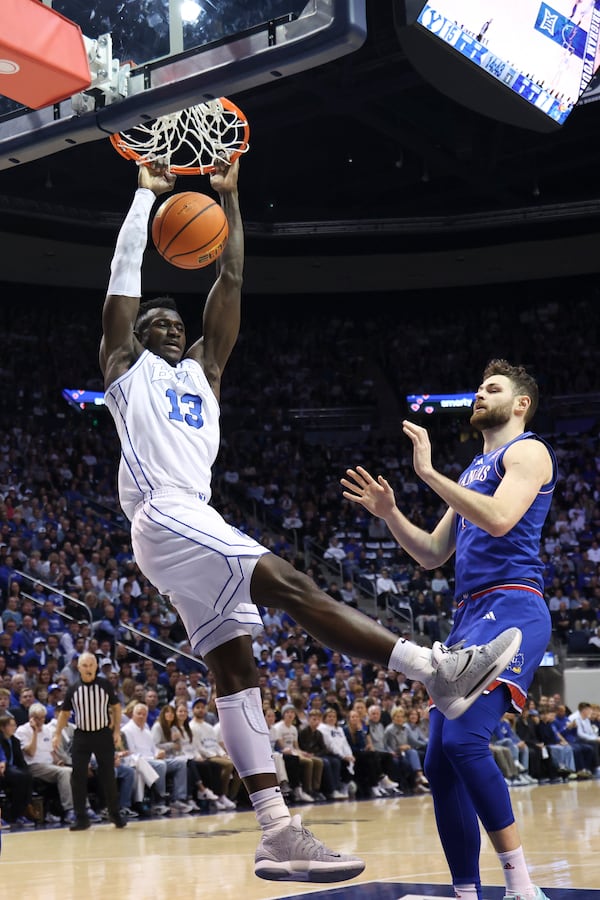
[131,490,270,656]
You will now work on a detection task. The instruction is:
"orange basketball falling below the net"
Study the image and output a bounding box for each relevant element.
[152,191,229,269]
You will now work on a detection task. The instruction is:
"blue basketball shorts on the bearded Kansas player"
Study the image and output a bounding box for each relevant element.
[445,585,552,710]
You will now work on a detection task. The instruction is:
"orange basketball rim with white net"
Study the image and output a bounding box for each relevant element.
[110,97,250,175]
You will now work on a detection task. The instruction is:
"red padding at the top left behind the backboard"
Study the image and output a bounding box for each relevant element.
[0,0,92,109]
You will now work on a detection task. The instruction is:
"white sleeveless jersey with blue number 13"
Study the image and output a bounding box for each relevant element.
[105,350,220,520]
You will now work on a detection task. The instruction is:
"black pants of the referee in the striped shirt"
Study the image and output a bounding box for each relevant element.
[71,728,119,819]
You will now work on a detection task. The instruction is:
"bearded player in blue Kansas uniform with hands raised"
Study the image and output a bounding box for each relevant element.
[342,360,557,900]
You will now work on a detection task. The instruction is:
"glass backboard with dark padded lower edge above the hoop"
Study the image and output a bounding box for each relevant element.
[0,0,366,169]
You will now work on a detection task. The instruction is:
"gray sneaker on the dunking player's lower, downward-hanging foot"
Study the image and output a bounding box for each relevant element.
[254,816,365,882]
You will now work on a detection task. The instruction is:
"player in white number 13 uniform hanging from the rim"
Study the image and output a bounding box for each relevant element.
[100,161,521,881]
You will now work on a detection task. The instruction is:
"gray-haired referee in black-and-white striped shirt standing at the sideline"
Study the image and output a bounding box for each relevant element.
[53,653,127,831]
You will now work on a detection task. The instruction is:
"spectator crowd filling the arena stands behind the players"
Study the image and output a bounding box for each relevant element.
[0,284,600,828]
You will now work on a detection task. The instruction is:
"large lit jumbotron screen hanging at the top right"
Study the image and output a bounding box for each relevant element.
[399,0,600,130]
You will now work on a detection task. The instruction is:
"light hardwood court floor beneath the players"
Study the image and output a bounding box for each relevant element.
[0,781,600,900]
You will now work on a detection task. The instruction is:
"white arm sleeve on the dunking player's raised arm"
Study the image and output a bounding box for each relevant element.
[107,188,156,297]
